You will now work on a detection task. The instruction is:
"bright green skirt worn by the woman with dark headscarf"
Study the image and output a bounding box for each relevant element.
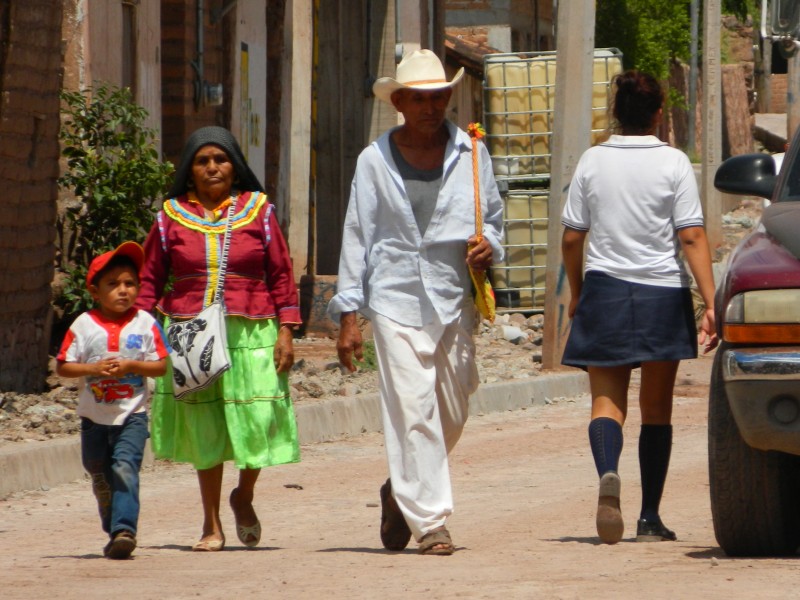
[150,317,300,469]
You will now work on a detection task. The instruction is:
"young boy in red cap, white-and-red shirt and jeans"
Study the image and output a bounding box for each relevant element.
[56,242,169,559]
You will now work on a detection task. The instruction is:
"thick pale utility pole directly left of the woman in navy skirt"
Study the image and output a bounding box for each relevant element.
[542,0,595,369]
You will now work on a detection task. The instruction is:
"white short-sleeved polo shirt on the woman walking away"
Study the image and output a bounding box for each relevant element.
[561,135,703,287]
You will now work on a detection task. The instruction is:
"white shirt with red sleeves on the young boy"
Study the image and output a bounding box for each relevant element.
[56,309,169,425]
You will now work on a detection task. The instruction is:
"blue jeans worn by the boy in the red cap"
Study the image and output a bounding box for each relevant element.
[81,413,150,537]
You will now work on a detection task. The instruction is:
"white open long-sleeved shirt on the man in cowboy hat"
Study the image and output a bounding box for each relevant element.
[328,122,503,327]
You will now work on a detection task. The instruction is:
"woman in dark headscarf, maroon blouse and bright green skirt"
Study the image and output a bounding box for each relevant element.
[137,127,300,551]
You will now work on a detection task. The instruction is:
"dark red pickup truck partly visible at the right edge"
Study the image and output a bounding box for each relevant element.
[708,142,800,556]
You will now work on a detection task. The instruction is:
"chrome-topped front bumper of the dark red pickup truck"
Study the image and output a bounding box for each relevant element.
[722,346,800,455]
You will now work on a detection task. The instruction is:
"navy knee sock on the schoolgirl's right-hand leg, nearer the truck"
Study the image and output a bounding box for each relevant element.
[639,425,672,521]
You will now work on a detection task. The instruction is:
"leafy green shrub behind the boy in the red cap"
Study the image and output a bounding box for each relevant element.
[54,83,174,320]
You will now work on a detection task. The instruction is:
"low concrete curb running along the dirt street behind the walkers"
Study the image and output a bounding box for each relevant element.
[0,371,589,499]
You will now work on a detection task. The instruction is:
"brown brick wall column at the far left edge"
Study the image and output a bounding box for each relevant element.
[0,0,62,392]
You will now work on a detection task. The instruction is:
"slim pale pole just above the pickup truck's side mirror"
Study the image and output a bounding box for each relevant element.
[700,0,722,253]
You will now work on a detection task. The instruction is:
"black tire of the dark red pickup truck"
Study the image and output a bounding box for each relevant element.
[708,347,800,556]
